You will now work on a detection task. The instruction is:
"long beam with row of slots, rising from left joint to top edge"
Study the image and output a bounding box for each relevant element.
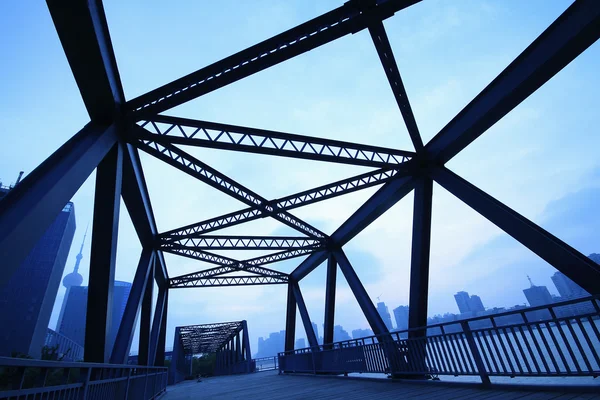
[127,0,420,120]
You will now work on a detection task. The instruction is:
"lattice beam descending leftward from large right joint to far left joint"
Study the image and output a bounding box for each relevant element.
[160,167,411,241]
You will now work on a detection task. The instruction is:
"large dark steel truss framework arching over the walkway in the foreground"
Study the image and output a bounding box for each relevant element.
[0,0,600,390]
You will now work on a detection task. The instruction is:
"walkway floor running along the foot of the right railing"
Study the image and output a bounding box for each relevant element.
[161,371,600,400]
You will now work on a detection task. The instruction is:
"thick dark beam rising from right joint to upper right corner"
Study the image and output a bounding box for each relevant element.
[425,0,600,164]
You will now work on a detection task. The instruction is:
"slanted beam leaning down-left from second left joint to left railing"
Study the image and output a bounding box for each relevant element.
[110,247,154,364]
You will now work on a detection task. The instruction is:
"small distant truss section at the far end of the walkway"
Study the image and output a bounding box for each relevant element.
[169,321,254,384]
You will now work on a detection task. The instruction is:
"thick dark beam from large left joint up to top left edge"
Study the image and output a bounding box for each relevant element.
[46,0,125,122]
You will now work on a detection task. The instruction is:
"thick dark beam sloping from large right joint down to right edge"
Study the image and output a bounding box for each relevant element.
[431,167,600,294]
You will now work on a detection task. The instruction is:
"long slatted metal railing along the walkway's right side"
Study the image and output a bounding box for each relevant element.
[279,296,600,383]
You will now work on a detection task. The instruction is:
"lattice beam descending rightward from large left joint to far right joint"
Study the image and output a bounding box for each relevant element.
[135,127,326,239]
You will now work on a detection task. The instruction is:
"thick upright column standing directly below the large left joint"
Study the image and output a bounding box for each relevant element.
[84,143,123,363]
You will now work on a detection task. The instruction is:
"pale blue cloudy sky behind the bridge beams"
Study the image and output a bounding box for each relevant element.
[0,0,600,352]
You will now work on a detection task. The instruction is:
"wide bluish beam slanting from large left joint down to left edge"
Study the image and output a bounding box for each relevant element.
[0,123,117,287]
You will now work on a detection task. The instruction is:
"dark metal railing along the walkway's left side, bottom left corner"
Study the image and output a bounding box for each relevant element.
[0,357,167,400]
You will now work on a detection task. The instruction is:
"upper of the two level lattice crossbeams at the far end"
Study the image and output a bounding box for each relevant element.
[161,235,321,250]
